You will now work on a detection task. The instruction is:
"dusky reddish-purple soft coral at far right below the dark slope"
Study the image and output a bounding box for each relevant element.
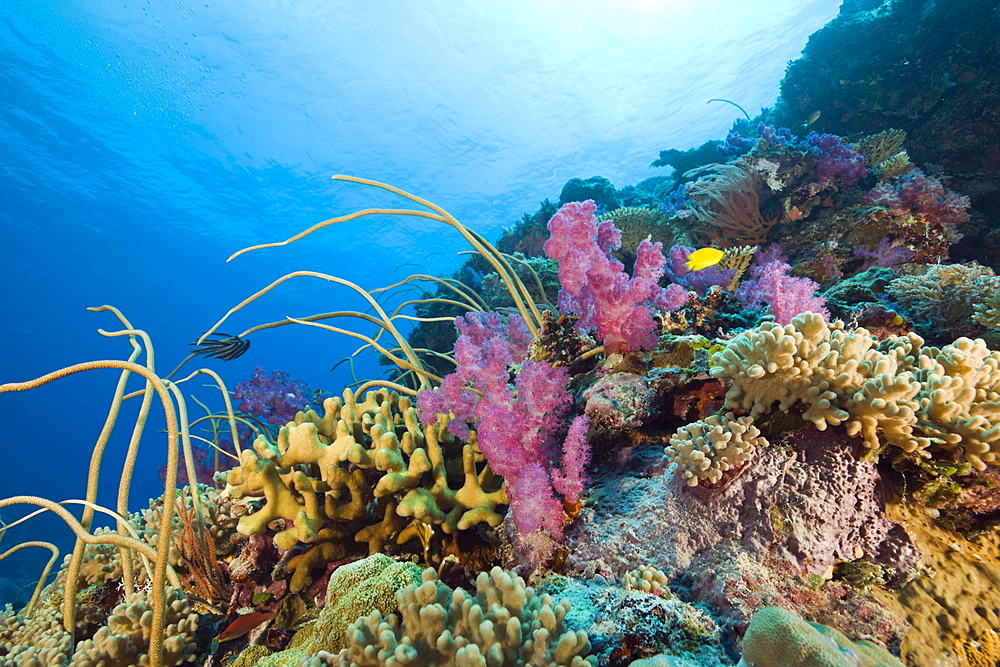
[862,169,970,227]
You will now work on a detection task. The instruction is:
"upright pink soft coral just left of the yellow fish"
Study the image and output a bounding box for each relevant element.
[545,200,687,352]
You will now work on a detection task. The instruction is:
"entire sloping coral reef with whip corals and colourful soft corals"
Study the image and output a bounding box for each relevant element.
[0,6,1000,667]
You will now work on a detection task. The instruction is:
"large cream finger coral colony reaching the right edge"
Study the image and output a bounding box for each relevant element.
[712,313,1000,470]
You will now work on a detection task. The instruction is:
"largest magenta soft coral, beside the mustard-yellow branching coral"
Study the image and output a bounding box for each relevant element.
[417,313,589,560]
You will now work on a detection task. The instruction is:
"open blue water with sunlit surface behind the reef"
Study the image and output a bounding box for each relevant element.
[0,0,839,603]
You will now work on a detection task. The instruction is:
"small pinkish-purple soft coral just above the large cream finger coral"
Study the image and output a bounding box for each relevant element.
[736,245,830,325]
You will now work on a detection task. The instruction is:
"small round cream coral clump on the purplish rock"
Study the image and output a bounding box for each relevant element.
[663,412,767,486]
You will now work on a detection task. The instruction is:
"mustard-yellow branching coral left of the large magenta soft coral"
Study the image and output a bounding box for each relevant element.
[227,389,508,590]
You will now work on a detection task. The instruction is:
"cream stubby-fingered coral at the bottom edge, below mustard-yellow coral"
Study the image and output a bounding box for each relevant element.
[340,567,597,667]
